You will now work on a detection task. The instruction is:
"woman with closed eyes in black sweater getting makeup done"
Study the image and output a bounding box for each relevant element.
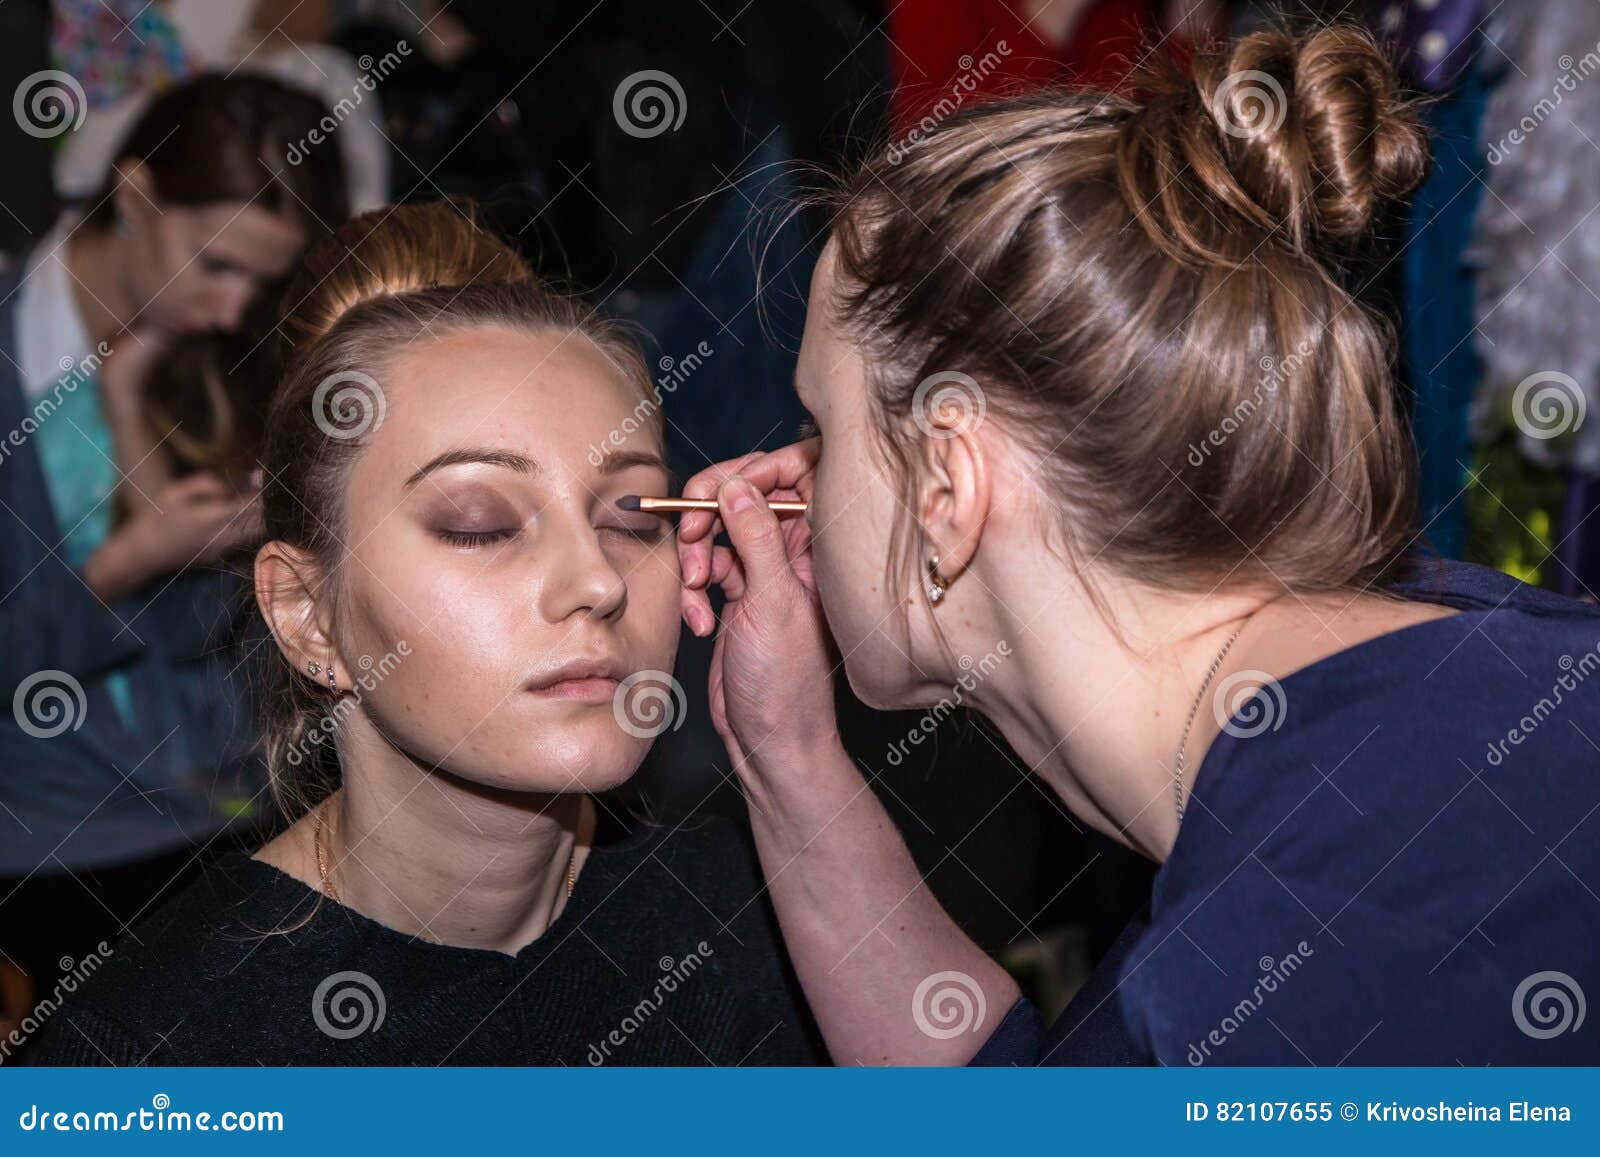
[23,205,818,1064]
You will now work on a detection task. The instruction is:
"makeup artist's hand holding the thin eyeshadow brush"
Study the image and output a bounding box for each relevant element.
[678,438,837,786]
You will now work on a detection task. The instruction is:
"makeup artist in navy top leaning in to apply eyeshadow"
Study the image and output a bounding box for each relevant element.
[680,27,1600,1064]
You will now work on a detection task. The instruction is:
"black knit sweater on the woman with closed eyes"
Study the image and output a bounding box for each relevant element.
[22,809,826,1066]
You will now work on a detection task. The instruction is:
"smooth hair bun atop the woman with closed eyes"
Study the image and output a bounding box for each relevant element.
[282,202,538,357]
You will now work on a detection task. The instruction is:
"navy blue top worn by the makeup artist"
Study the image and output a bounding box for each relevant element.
[974,563,1600,1066]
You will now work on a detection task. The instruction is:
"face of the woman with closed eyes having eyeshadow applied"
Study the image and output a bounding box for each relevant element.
[336,326,678,792]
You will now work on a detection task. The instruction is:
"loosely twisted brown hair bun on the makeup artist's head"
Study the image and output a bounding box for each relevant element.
[1130,26,1429,260]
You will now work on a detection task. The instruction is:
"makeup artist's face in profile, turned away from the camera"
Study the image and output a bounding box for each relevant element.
[795,243,915,709]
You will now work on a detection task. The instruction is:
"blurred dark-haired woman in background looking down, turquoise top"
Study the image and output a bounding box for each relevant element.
[0,75,344,1036]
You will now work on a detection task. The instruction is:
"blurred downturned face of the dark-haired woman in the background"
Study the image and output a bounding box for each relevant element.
[125,194,306,334]
